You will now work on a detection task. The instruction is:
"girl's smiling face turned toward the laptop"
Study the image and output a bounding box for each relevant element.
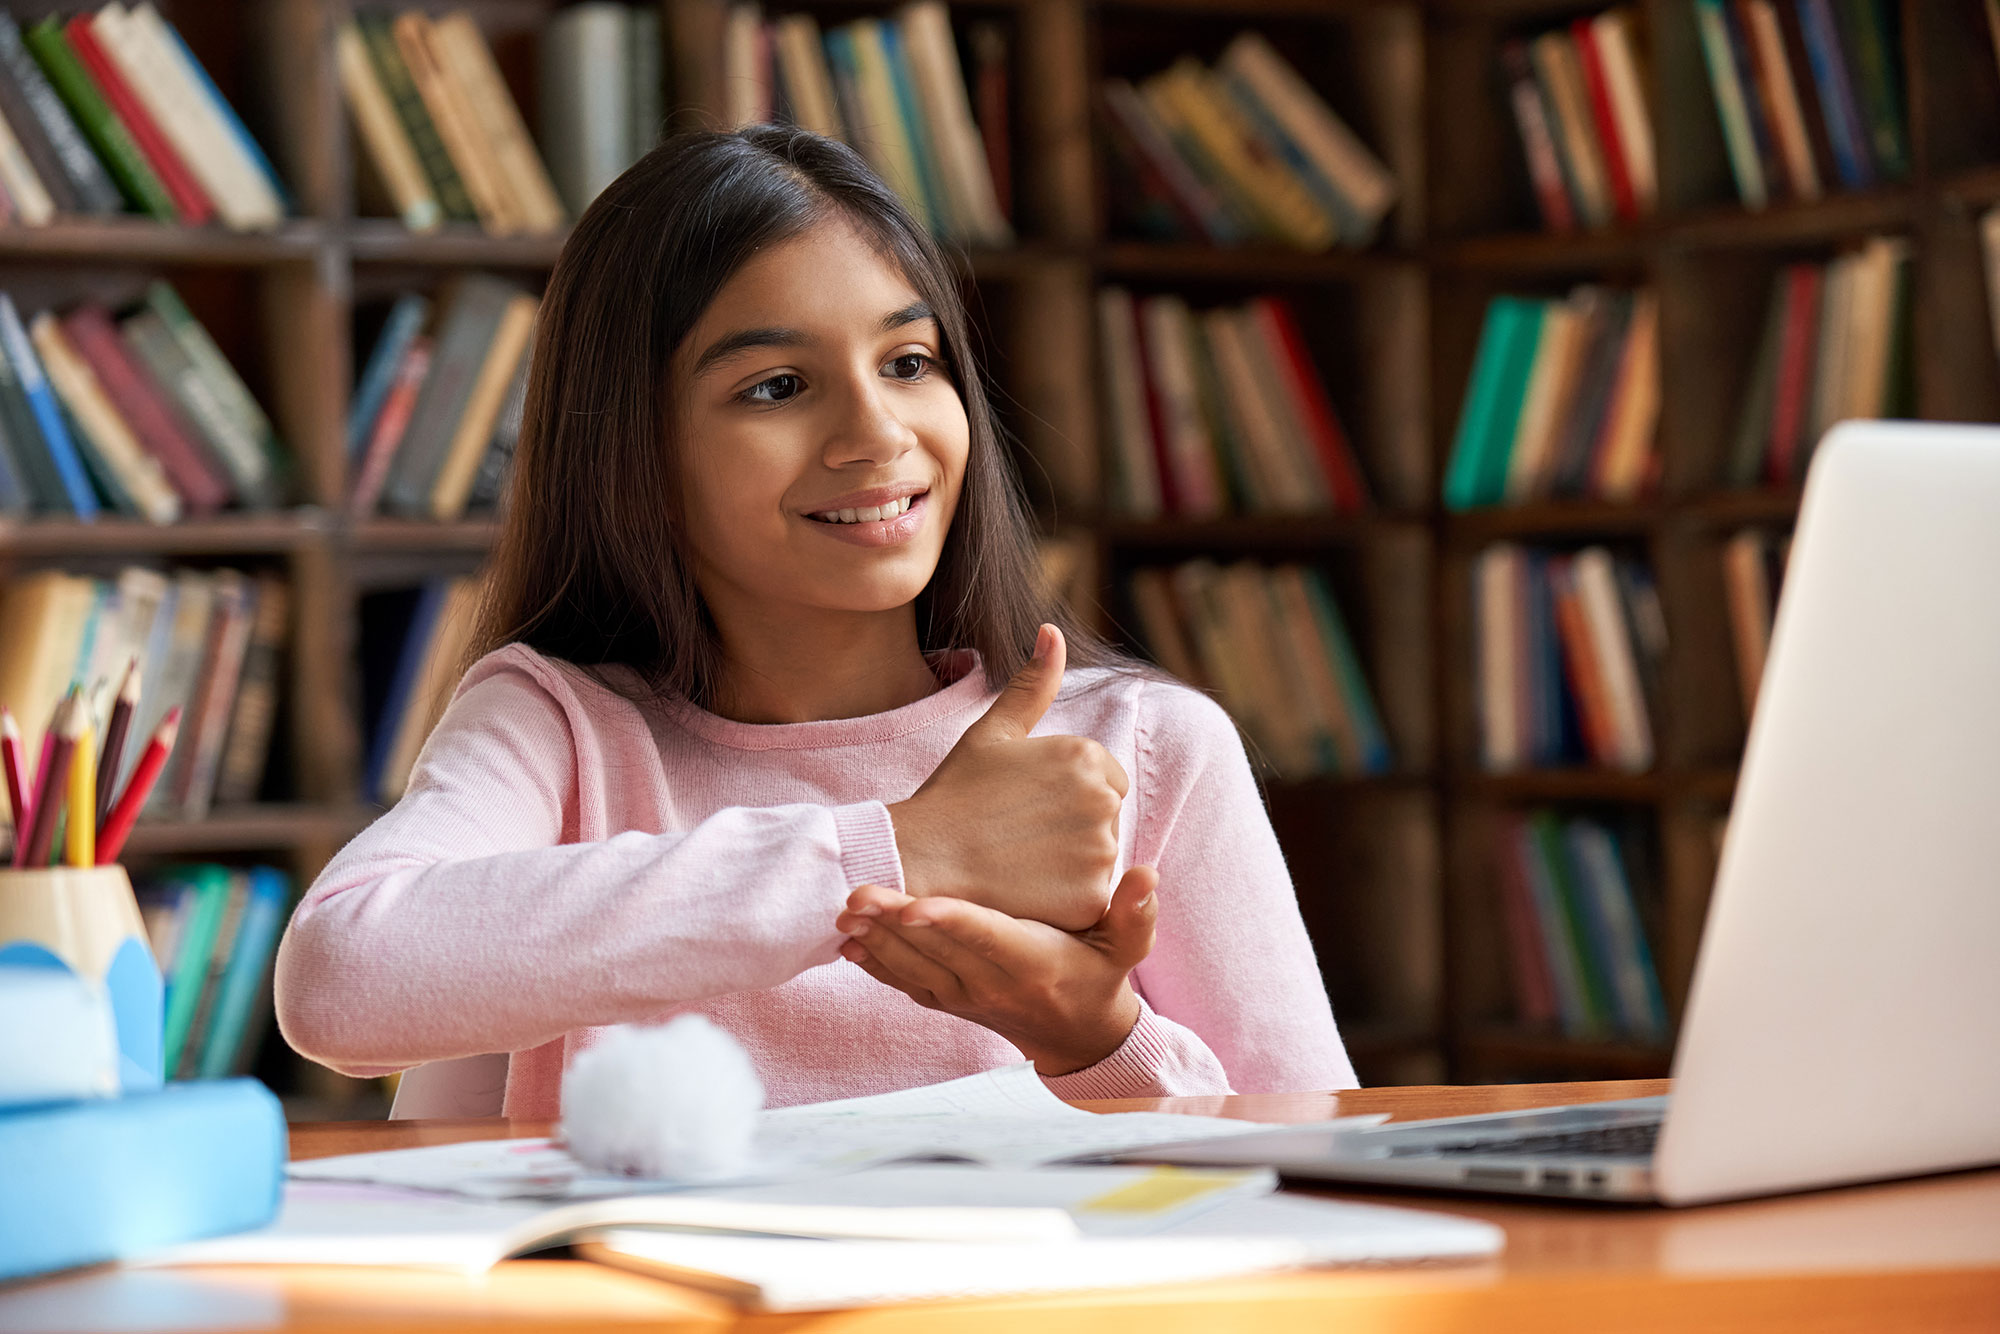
[672,216,970,626]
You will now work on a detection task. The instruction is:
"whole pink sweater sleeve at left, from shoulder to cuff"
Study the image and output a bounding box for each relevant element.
[276,666,902,1076]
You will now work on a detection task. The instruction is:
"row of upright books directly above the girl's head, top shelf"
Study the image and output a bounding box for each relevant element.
[720,0,1014,246]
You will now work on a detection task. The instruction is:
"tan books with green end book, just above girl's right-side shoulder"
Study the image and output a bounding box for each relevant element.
[1130,560,1394,778]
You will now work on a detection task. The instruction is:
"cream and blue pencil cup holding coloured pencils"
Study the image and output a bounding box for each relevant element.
[0,866,164,1094]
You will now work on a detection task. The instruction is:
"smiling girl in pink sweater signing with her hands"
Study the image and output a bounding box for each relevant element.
[276,128,1354,1118]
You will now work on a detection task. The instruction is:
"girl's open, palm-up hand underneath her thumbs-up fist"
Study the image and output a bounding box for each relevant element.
[834,866,1160,1076]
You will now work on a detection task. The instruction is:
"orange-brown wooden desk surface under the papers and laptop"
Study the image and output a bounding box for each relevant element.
[0,1080,2000,1334]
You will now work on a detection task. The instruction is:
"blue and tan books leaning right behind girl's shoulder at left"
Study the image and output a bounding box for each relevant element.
[360,578,480,806]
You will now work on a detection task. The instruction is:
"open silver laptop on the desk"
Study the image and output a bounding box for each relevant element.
[1146,422,2000,1204]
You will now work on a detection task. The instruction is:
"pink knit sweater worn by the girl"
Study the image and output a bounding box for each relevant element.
[276,644,1356,1118]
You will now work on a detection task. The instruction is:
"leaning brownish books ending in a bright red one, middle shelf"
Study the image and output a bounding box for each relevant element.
[1098,288,1368,518]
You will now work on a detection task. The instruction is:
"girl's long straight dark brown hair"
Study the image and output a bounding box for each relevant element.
[468,126,1130,704]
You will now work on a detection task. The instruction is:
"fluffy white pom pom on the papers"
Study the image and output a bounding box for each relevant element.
[562,1014,764,1182]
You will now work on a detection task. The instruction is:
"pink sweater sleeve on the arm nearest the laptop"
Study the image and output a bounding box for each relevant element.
[1048,682,1358,1098]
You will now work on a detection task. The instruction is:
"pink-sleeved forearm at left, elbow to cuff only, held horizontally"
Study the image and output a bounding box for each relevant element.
[276,804,898,1074]
